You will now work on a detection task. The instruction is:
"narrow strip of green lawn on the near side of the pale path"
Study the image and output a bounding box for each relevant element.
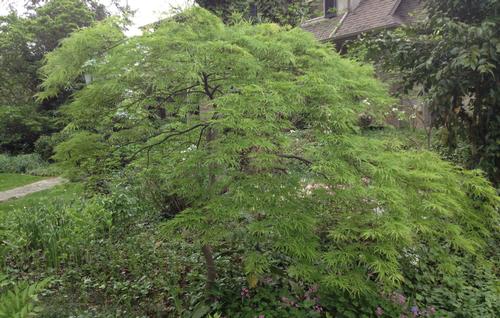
[0,183,83,213]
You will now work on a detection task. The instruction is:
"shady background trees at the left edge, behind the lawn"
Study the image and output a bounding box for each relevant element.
[0,0,111,153]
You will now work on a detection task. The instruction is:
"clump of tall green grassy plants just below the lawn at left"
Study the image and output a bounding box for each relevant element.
[3,200,111,269]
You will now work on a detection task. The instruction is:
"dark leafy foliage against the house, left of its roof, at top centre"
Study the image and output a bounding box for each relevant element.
[195,0,310,26]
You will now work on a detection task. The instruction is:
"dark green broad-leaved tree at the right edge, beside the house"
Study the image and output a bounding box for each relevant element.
[354,0,500,184]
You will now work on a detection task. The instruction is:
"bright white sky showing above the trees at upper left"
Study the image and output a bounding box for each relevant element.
[0,0,192,35]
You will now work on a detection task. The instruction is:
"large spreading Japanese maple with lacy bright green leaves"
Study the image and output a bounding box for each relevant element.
[36,8,499,313]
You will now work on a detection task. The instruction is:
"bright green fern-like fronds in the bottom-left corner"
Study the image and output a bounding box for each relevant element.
[0,274,48,318]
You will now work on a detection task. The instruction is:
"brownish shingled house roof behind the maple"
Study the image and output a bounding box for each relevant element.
[301,0,422,41]
